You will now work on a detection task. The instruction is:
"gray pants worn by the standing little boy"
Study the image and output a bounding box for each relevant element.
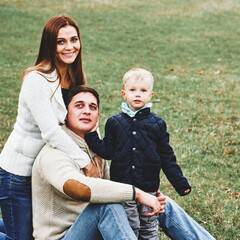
[123,192,159,240]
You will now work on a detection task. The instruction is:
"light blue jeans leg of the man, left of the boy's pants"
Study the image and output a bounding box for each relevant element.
[62,203,137,240]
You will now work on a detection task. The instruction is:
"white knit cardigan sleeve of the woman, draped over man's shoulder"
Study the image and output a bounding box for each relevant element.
[21,72,90,168]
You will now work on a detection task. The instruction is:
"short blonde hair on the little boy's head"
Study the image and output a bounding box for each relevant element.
[123,68,154,91]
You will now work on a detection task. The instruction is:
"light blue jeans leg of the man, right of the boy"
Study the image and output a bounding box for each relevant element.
[158,197,215,240]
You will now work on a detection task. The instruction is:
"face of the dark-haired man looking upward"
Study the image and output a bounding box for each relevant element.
[66,92,99,137]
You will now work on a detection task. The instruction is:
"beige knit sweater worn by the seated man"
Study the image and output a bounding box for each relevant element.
[32,127,133,240]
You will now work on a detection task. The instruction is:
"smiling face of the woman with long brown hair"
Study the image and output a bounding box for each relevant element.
[56,25,81,65]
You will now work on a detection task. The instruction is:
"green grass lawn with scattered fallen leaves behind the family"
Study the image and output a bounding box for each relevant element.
[0,0,240,240]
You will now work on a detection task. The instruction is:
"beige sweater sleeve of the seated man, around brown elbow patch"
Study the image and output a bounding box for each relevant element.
[38,148,133,203]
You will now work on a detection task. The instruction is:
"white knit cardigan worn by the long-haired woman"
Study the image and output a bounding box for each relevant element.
[0,71,90,176]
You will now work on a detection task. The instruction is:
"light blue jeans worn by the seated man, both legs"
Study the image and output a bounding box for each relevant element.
[62,197,215,240]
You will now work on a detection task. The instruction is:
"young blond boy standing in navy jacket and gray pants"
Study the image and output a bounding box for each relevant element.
[85,68,191,239]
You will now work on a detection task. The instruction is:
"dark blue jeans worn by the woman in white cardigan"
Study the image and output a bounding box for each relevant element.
[0,168,33,240]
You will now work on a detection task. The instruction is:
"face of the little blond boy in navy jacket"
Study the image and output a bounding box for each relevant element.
[122,79,153,112]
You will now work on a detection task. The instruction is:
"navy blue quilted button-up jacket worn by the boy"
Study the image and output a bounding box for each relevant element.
[85,108,191,195]
